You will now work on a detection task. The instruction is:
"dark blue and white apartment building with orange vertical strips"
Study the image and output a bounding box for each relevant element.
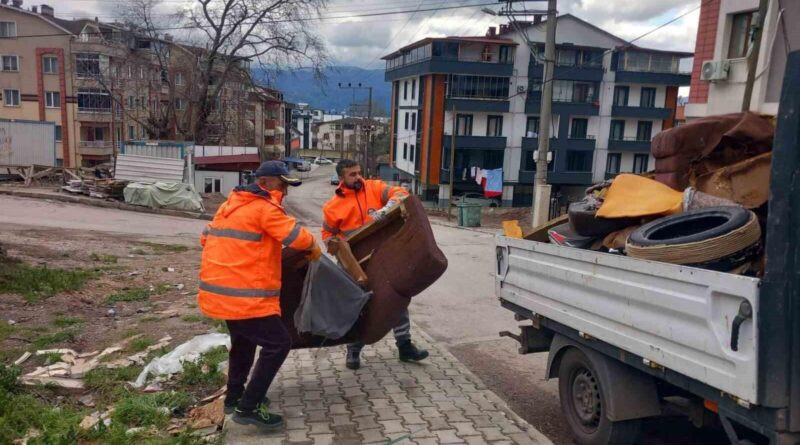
[384,14,691,206]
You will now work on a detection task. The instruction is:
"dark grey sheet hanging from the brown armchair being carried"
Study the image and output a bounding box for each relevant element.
[294,256,372,340]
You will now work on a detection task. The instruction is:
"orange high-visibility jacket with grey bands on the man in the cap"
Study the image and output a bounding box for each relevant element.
[197,184,314,320]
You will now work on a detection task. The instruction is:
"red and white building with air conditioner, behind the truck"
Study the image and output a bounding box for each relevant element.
[686,0,800,120]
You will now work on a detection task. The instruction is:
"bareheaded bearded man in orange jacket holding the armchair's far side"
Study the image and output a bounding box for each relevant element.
[322,159,428,369]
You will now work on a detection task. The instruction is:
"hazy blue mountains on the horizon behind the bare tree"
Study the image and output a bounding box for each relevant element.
[254,66,392,115]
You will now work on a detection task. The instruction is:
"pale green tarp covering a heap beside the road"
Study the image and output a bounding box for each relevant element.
[123,182,204,212]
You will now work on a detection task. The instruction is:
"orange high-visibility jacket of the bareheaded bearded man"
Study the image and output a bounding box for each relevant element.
[322,179,408,240]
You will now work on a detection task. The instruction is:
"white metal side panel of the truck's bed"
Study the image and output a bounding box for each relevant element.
[495,235,760,404]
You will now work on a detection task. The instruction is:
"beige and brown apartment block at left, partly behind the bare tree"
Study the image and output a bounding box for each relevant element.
[0,0,284,167]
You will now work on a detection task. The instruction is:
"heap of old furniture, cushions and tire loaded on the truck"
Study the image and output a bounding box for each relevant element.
[506,112,775,276]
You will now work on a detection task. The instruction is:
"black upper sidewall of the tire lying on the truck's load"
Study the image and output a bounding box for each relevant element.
[628,207,751,247]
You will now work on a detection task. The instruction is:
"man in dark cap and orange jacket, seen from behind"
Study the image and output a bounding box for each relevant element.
[197,161,322,430]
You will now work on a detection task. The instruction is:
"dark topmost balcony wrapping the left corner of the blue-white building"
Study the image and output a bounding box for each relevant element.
[384,56,514,82]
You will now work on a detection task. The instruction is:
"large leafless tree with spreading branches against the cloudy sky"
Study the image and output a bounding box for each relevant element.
[185,0,327,141]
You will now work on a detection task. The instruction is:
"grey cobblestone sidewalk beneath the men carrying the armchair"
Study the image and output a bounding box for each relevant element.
[225,326,551,445]
